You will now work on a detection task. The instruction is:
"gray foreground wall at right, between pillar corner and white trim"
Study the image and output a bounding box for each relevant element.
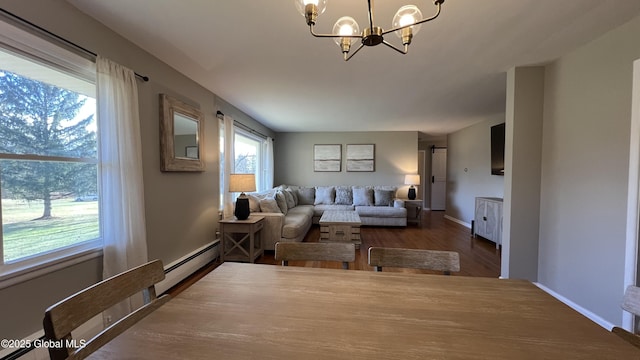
[538,17,640,324]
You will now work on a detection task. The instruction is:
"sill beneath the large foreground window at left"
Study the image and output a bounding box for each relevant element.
[0,248,102,289]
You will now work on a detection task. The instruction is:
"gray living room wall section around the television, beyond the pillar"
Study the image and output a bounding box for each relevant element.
[445,118,505,225]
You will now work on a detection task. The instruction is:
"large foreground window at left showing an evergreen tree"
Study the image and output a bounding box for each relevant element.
[0,19,102,279]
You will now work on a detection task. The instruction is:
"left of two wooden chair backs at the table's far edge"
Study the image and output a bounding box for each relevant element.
[275,242,356,270]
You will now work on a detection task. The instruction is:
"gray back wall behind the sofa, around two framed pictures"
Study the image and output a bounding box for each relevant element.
[274,131,418,188]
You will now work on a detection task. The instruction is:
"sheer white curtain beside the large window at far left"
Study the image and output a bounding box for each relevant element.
[96,56,147,322]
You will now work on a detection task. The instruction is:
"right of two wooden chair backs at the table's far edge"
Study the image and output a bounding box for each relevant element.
[369,247,460,275]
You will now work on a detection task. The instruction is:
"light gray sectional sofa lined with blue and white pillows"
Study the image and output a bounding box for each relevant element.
[248,185,407,250]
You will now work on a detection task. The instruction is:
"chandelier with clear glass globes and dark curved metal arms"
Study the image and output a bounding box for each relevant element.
[295,0,444,61]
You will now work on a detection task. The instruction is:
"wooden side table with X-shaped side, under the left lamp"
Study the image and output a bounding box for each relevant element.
[220,215,264,262]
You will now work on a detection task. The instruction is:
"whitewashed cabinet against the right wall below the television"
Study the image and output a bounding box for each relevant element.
[473,197,502,247]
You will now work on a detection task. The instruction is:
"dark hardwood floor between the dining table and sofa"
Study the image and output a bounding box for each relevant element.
[168,211,501,296]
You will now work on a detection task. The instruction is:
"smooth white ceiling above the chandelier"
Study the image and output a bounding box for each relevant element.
[68,0,640,137]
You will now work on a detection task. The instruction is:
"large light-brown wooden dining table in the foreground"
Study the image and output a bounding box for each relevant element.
[91,262,640,360]
